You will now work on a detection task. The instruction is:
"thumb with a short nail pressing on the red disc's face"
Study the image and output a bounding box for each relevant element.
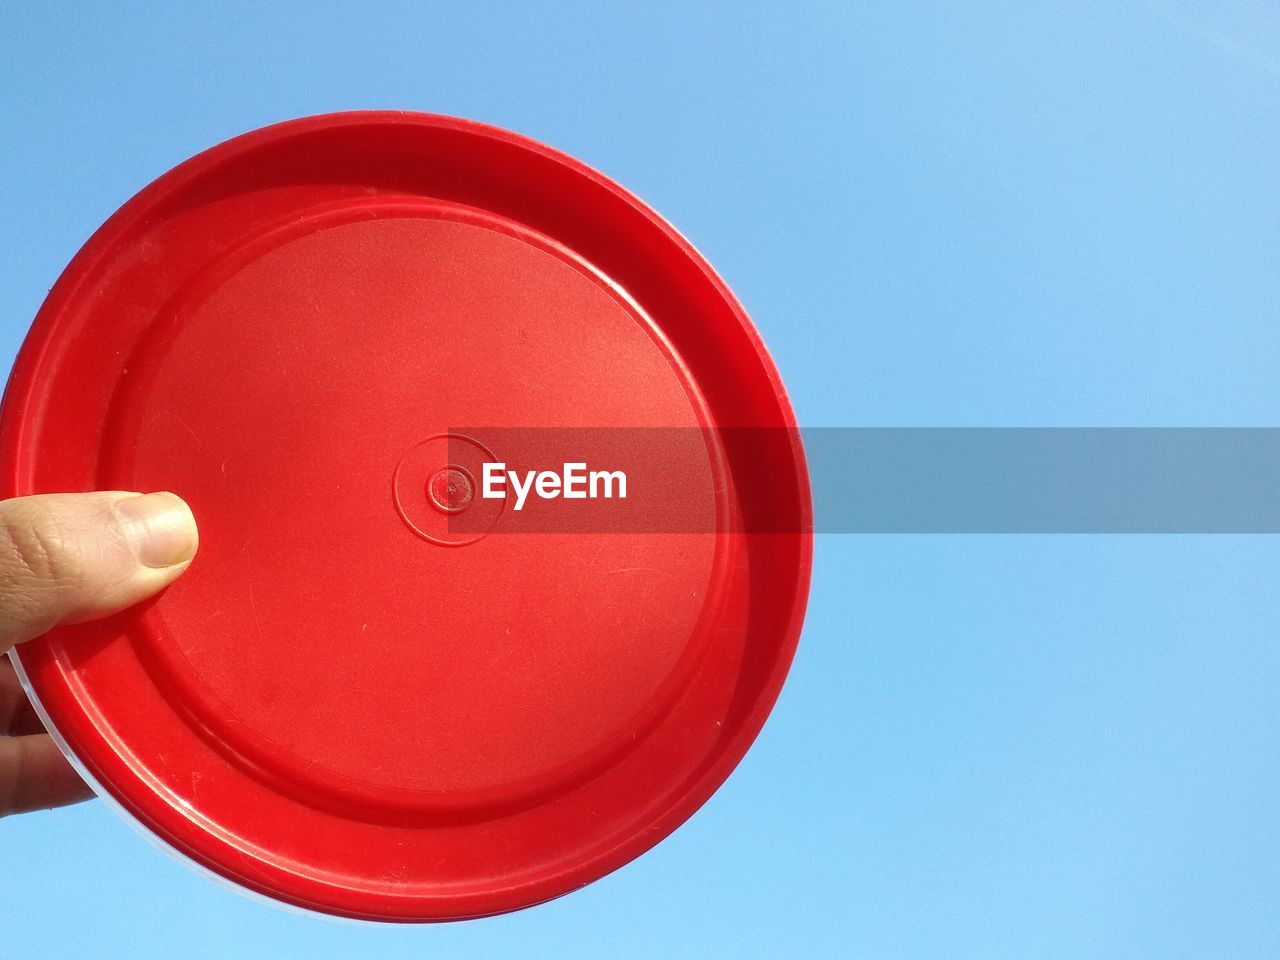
[0,492,198,653]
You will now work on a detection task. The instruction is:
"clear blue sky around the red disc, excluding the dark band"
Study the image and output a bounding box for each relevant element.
[0,0,1280,960]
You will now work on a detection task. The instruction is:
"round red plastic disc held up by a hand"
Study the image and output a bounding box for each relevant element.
[0,113,812,920]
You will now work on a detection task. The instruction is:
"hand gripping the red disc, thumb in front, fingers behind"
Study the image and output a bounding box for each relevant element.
[0,492,198,817]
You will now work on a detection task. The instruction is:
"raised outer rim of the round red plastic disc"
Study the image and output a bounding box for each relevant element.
[0,110,813,922]
